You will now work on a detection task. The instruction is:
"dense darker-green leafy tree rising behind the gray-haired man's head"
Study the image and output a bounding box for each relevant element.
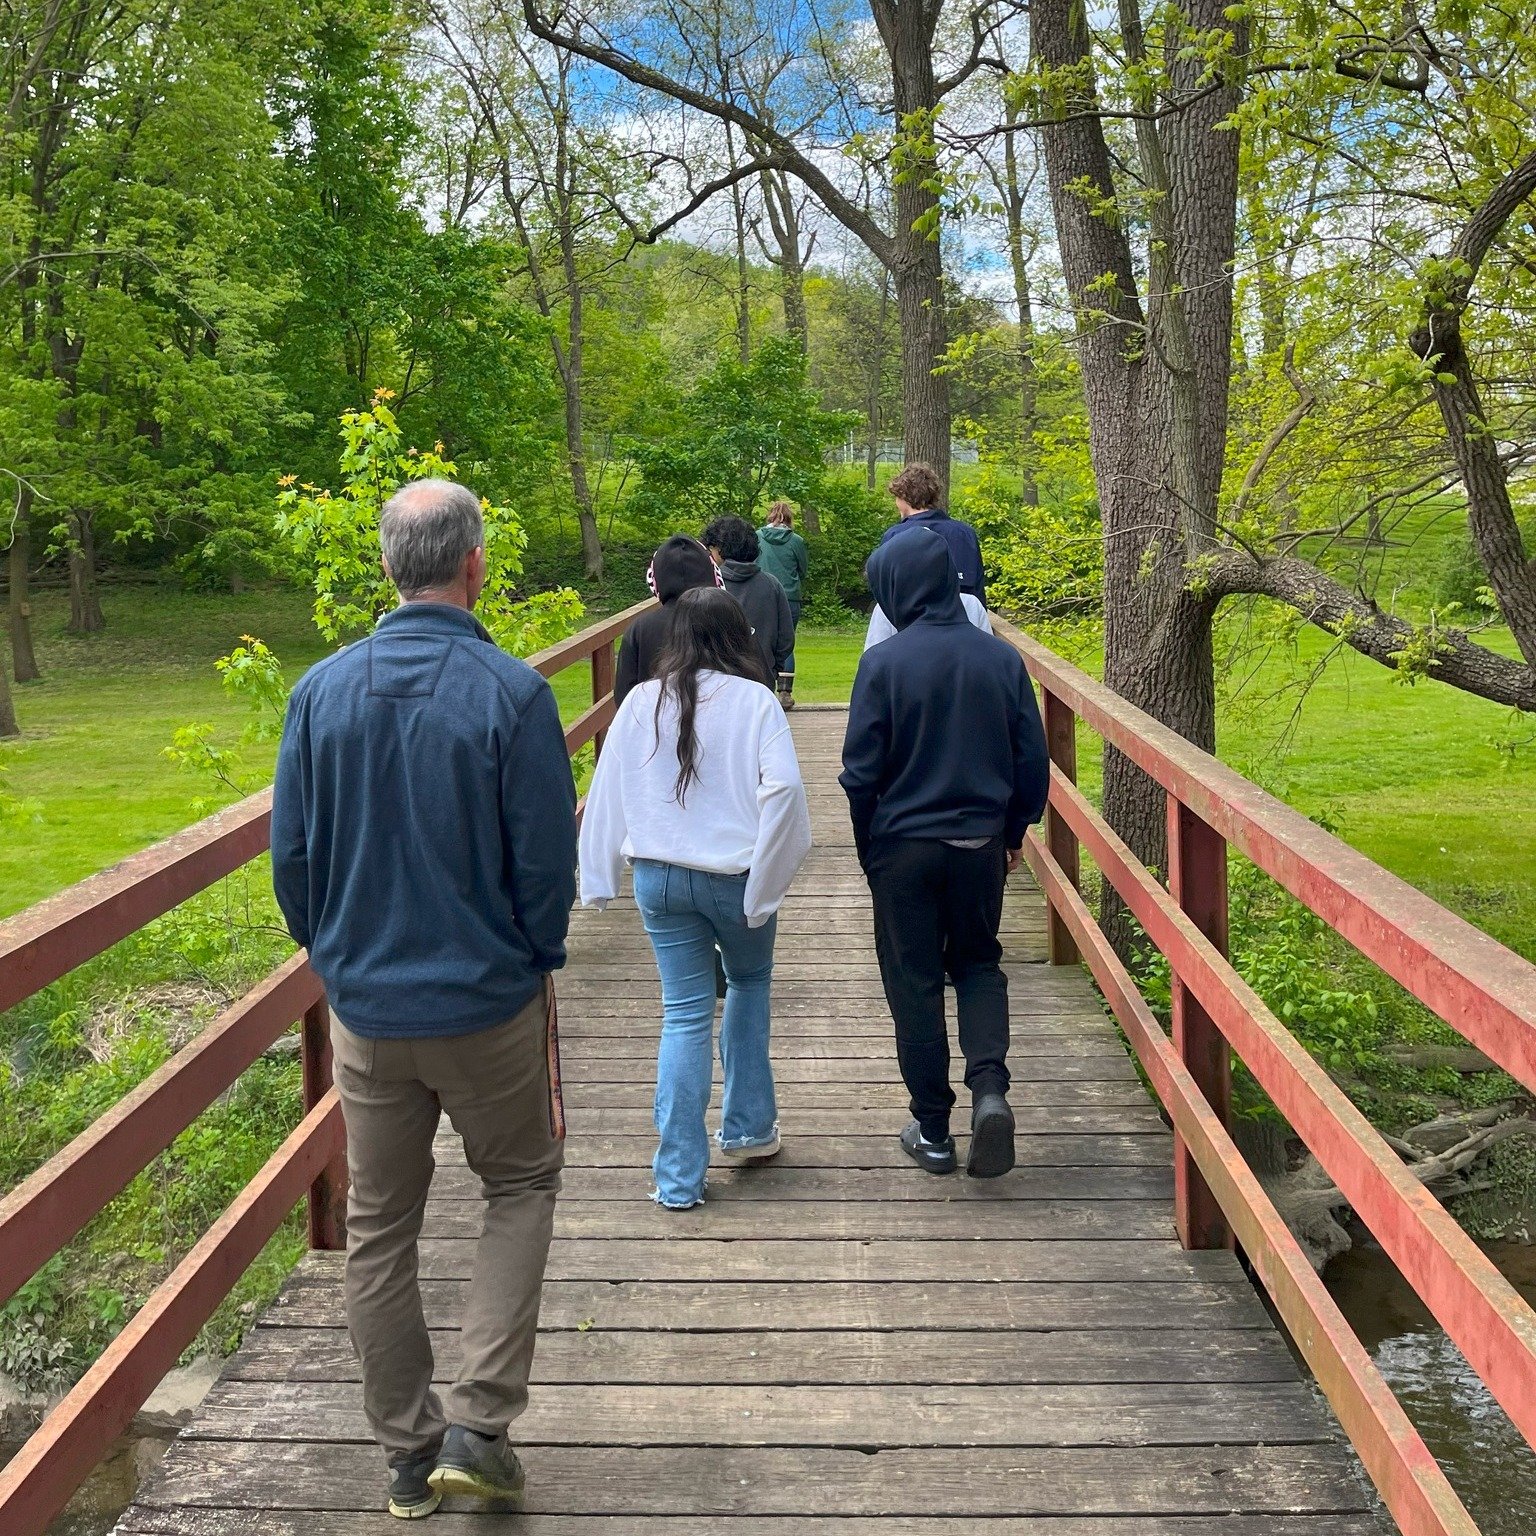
[268,0,558,498]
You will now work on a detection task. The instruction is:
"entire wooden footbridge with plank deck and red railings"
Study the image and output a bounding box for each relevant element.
[0,602,1536,1536]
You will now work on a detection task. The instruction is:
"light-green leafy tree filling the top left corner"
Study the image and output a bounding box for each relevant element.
[0,0,300,630]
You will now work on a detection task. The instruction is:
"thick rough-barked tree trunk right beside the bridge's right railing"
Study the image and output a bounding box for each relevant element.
[1031,0,1240,949]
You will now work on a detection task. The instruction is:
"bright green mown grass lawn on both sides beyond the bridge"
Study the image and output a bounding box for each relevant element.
[0,588,1536,955]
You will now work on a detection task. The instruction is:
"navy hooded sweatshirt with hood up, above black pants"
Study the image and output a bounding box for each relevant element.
[839,531,1051,862]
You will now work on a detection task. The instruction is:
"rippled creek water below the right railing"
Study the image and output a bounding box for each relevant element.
[1324,1243,1536,1536]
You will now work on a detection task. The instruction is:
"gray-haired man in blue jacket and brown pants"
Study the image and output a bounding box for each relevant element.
[272,479,576,1519]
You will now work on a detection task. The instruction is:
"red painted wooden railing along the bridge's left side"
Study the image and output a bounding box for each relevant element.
[0,604,650,1536]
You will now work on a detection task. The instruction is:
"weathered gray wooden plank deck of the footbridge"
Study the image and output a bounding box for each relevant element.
[118,711,1384,1536]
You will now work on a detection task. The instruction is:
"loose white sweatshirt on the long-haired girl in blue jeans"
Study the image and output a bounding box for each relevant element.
[581,671,811,928]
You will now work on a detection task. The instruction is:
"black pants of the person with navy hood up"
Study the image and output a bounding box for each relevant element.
[865,837,1008,1141]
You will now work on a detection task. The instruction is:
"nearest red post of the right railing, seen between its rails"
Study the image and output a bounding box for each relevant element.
[1167,794,1232,1249]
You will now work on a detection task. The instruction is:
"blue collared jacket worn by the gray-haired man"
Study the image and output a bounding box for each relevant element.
[272,602,576,1038]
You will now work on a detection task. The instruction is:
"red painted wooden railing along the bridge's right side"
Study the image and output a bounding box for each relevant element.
[997,622,1536,1536]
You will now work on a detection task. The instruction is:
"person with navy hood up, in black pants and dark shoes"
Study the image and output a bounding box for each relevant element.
[839,528,1051,1178]
